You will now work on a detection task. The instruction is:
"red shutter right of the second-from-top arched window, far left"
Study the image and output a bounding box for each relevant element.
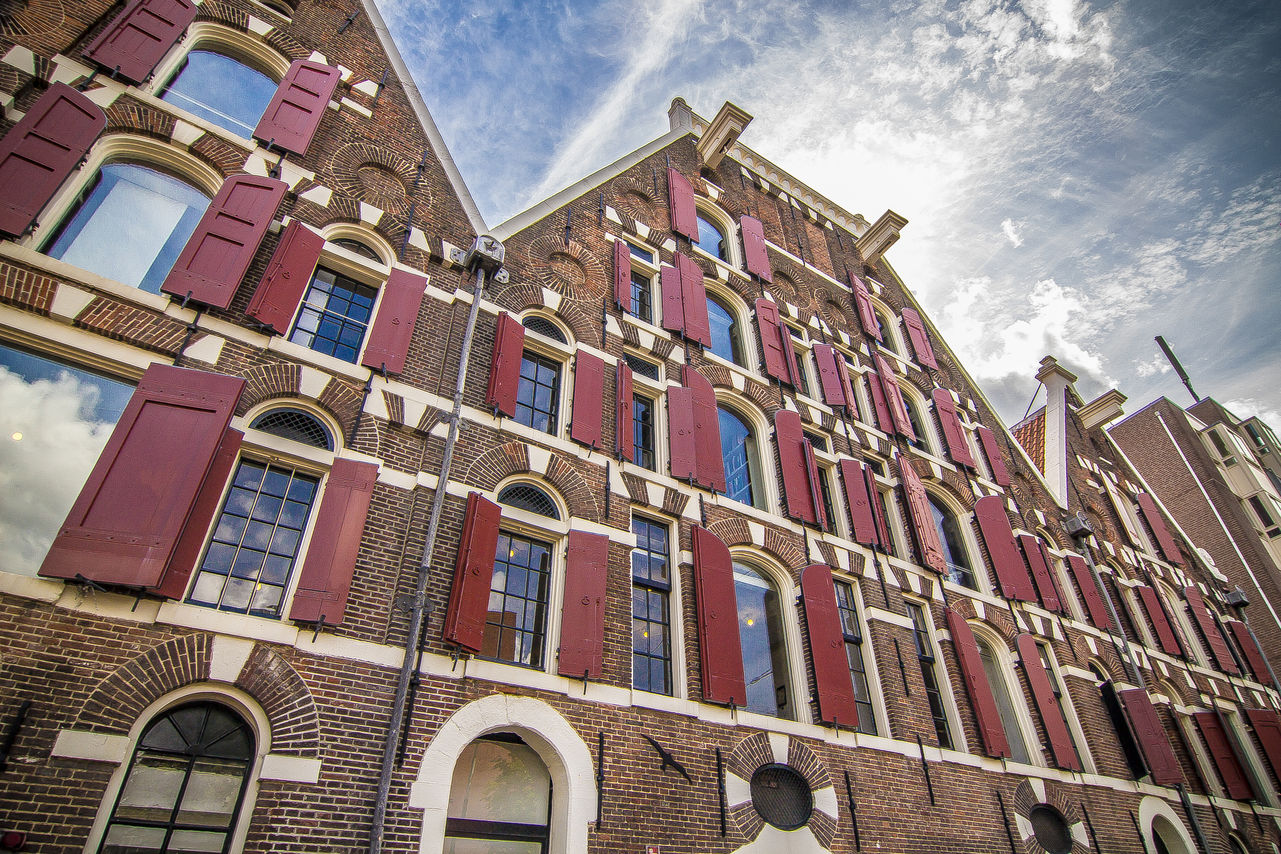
[160,175,288,309]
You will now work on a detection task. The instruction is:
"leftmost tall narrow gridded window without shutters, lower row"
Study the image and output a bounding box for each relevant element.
[632,516,673,694]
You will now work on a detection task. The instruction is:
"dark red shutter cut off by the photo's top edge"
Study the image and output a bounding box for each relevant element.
[85,0,196,83]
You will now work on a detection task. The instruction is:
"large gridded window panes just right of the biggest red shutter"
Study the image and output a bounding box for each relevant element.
[190,460,318,617]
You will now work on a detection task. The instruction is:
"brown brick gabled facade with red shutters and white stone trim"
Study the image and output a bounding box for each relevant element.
[0,0,1281,854]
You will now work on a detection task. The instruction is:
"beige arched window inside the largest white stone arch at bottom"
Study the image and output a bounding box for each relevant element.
[445,732,552,854]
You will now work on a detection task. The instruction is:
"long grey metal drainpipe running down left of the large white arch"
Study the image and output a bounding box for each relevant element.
[369,266,485,854]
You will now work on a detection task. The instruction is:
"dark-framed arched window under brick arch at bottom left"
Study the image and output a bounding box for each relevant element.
[99,702,255,854]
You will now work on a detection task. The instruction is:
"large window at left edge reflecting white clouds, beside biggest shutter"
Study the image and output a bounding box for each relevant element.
[0,344,133,575]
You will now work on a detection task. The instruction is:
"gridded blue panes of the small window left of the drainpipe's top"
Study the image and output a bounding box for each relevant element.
[290,268,378,362]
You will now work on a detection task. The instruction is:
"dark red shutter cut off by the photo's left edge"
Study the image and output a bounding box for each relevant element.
[0,83,106,237]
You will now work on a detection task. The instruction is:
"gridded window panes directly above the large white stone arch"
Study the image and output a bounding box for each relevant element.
[482,531,552,667]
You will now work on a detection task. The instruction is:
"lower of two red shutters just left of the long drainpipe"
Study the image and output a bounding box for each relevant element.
[290,457,378,626]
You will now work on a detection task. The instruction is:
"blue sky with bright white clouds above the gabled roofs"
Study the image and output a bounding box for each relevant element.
[378,0,1281,430]
